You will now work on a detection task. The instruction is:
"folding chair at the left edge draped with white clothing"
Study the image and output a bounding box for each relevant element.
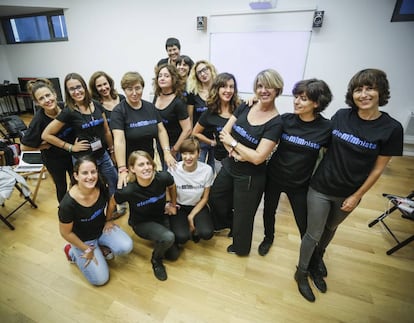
[0,166,37,230]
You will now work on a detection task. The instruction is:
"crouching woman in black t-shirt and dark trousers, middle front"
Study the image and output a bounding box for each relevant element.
[115,150,179,280]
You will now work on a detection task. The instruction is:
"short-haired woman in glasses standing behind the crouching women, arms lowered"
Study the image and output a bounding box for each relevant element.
[111,72,176,186]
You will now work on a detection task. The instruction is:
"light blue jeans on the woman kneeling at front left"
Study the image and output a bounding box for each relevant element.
[69,226,133,286]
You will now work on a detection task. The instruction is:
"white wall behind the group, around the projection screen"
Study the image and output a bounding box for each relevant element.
[0,0,414,125]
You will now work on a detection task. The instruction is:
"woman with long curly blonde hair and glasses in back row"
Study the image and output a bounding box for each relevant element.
[187,60,217,170]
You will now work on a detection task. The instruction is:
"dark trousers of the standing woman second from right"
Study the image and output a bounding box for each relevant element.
[263,184,308,241]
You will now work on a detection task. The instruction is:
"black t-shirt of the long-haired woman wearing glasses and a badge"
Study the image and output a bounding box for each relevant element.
[56,101,108,159]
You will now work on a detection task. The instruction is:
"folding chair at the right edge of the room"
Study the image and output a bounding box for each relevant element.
[368,191,414,255]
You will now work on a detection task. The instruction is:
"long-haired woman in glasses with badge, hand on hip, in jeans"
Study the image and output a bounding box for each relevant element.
[42,73,117,210]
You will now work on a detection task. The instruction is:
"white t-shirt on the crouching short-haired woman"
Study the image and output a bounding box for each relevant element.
[168,161,214,206]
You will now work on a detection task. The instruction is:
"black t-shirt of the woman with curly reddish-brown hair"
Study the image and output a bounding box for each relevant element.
[154,97,188,146]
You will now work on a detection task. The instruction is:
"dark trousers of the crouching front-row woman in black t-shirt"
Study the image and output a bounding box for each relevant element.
[132,218,179,260]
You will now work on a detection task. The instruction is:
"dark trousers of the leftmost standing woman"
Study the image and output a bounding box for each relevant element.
[44,155,73,202]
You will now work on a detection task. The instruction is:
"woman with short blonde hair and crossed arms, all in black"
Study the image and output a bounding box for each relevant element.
[209,69,283,256]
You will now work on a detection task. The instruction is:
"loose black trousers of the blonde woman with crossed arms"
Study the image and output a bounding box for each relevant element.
[209,167,266,256]
